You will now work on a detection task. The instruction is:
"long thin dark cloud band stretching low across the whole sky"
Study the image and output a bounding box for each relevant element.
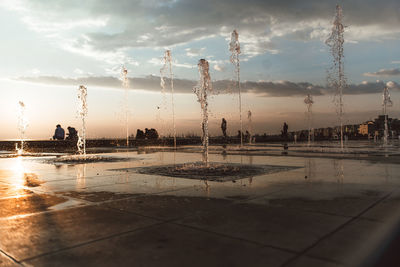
[17,75,400,97]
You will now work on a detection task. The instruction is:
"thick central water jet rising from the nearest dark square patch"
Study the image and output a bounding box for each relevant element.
[193,59,212,166]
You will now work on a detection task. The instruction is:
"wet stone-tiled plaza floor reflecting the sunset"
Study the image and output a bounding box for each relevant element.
[0,152,400,266]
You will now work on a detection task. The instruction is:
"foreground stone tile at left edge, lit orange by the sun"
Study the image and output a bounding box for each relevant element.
[0,206,157,260]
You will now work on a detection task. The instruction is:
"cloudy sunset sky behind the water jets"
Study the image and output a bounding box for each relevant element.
[0,0,400,140]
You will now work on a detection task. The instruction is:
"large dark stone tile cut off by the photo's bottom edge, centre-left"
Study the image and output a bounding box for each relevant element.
[27,224,293,267]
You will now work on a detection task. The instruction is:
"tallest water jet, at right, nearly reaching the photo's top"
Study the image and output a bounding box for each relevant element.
[325,5,347,150]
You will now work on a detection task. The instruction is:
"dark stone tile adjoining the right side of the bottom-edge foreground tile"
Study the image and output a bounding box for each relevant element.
[178,204,348,251]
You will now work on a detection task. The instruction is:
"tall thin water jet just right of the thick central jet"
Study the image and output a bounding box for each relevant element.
[229,30,243,146]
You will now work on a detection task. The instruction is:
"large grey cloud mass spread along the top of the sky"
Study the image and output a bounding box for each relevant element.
[2,0,400,63]
